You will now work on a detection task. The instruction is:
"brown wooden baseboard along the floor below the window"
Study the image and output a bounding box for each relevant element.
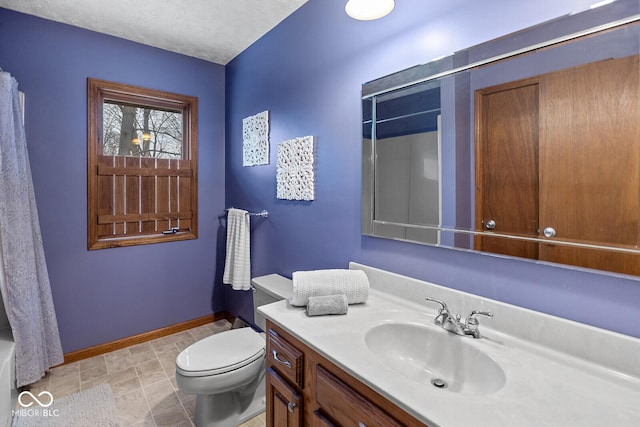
[58,311,235,366]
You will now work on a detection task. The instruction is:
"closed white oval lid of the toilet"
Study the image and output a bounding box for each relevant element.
[176,328,266,376]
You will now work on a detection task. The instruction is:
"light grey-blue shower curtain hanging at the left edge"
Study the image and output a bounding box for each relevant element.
[0,71,64,387]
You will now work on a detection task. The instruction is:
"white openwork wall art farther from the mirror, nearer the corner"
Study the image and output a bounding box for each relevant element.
[242,111,269,166]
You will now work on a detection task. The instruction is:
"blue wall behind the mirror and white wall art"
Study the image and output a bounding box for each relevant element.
[226,0,640,337]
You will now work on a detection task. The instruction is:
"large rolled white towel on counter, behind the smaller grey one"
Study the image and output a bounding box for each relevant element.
[289,269,369,306]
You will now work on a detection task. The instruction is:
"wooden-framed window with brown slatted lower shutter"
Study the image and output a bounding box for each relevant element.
[87,79,198,250]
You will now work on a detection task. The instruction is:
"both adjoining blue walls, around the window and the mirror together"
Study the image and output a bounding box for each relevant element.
[0,0,640,358]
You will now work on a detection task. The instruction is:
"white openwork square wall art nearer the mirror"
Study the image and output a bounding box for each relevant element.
[276,136,315,200]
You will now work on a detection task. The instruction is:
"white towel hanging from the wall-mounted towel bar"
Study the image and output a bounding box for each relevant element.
[222,208,251,291]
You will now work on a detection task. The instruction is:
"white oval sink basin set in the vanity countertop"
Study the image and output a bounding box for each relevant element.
[365,322,506,395]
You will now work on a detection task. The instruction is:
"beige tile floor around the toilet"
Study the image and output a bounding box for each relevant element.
[25,320,265,427]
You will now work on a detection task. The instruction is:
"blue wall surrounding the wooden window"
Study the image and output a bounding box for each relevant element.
[0,9,225,352]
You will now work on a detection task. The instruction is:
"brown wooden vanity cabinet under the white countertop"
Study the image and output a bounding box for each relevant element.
[267,320,425,427]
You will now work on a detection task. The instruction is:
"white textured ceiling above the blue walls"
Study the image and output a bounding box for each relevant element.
[0,0,307,65]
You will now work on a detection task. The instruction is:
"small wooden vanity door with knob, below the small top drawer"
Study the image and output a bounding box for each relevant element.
[267,368,302,427]
